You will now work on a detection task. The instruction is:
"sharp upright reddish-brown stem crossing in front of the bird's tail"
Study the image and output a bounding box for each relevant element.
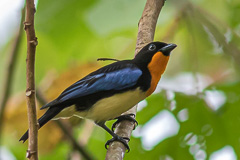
[24,0,38,160]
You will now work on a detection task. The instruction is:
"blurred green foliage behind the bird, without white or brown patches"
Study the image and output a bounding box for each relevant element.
[0,0,240,160]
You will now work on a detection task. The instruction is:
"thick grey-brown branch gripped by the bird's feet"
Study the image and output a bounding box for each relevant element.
[106,0,164,160]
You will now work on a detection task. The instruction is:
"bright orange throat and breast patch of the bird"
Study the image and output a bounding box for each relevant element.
[146,52,169,97]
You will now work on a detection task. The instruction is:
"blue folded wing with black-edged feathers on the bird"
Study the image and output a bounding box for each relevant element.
[53,64,142,105]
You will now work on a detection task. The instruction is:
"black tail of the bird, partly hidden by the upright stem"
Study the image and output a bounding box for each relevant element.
[19,107,62,143]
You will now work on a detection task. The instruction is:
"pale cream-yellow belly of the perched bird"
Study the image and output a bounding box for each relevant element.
[74,88,145,122]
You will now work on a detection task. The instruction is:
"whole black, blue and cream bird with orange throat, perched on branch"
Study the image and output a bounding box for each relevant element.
[19,42,177,151]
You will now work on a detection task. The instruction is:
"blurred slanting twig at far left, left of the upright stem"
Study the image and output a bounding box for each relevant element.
[0,8,25,145]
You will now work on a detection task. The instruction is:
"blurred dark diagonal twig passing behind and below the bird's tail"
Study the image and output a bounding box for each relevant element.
[36,89,94,160]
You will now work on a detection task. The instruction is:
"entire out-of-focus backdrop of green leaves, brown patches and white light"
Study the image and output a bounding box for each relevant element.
[0,0,240,160]
